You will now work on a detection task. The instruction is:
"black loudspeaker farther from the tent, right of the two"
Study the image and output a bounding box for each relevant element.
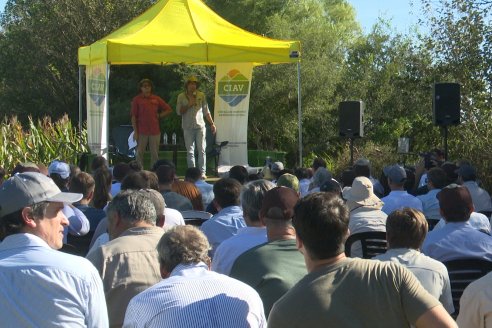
[432,83,461,126]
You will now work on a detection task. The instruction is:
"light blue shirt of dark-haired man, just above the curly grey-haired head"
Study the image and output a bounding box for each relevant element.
[201,206,246,257]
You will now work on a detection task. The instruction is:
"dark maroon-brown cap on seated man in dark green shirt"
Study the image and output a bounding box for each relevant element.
[260,187,299,220]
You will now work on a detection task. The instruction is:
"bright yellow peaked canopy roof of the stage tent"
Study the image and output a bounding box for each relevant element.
[79,0,300,65]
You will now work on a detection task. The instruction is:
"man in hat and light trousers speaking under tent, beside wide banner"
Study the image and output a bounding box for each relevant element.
[176,76,217,177]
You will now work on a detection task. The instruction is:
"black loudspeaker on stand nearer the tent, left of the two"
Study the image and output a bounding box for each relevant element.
[338,100,365,138]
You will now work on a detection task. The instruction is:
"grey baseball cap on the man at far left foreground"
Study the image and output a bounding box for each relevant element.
[0,172,82,217]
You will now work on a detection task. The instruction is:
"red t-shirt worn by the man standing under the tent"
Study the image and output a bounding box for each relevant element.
[131,94,172,136]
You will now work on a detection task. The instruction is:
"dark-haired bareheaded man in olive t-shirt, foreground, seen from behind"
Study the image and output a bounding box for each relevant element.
[268,192,456,328]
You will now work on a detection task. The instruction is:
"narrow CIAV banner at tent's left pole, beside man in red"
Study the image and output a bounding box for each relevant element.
[86,64,109,158]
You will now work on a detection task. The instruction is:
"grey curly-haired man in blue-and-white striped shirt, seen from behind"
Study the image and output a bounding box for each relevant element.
[123,225,266,328]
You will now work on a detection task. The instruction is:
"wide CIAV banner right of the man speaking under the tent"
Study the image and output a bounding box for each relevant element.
[214,63,253,172]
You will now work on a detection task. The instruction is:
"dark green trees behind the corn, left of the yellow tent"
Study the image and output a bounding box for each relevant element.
[0,0,151,119]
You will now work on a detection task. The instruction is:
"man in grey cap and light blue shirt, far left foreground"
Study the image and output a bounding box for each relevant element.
[0,172,108,327]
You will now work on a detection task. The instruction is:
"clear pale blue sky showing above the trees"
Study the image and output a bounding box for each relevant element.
[0,0,419,34]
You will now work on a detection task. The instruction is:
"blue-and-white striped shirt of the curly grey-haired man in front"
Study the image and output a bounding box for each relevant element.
[123,262,266,328]
